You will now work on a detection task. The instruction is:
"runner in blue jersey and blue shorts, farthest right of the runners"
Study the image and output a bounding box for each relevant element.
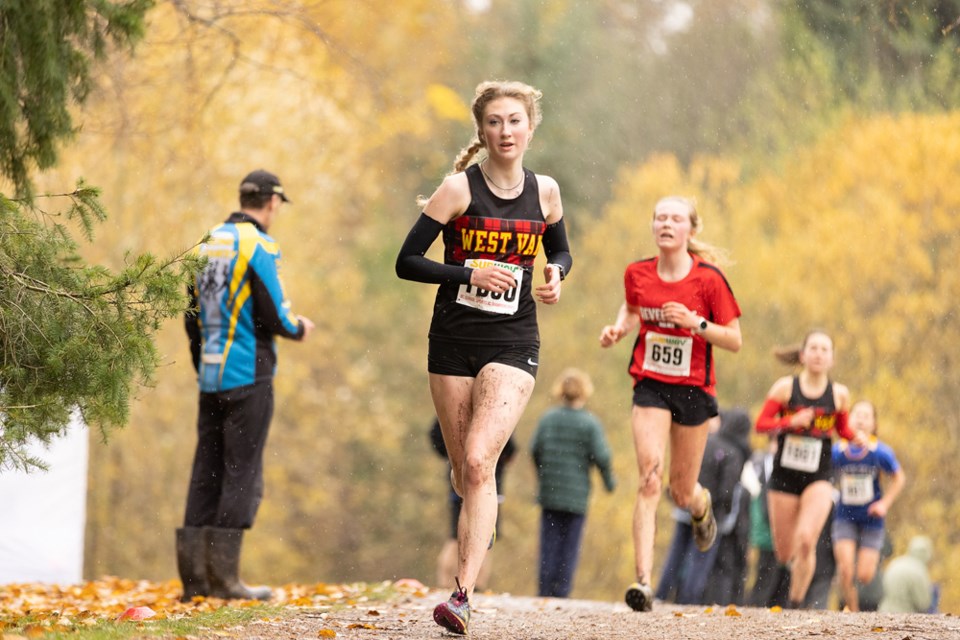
[831,400,906,611]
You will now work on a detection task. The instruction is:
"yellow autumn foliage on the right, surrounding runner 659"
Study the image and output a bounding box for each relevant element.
[552,113,960,610]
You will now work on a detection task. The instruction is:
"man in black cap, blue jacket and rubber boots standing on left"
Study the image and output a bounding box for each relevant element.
[177,169,314,602]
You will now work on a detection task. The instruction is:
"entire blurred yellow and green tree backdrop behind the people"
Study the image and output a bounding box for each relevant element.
[13,0,960,610]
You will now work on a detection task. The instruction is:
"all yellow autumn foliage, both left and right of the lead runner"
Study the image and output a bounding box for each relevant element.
[16,0,960,611]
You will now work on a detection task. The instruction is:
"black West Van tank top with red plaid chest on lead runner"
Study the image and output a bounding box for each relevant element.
[430,164,546,344]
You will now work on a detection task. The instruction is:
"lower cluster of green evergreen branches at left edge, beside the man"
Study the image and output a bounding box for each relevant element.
[0,181,199,470]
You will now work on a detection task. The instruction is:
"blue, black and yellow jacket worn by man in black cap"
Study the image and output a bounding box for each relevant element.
[185,212,304,393]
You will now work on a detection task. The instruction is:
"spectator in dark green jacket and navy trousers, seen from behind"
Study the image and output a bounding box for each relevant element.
[530,369,616,598]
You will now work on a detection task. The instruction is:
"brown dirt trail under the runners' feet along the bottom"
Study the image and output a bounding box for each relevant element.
[236,591,960,640]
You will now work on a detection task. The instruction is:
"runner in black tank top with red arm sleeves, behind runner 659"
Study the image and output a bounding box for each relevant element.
[757,331,852,608]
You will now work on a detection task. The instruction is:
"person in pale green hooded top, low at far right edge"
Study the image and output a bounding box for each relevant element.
[878,536,934,613]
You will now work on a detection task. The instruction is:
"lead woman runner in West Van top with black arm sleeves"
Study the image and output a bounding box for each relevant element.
[397,82,572,634]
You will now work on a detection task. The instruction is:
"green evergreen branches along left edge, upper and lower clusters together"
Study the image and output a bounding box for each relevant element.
[0,0,195,470]
